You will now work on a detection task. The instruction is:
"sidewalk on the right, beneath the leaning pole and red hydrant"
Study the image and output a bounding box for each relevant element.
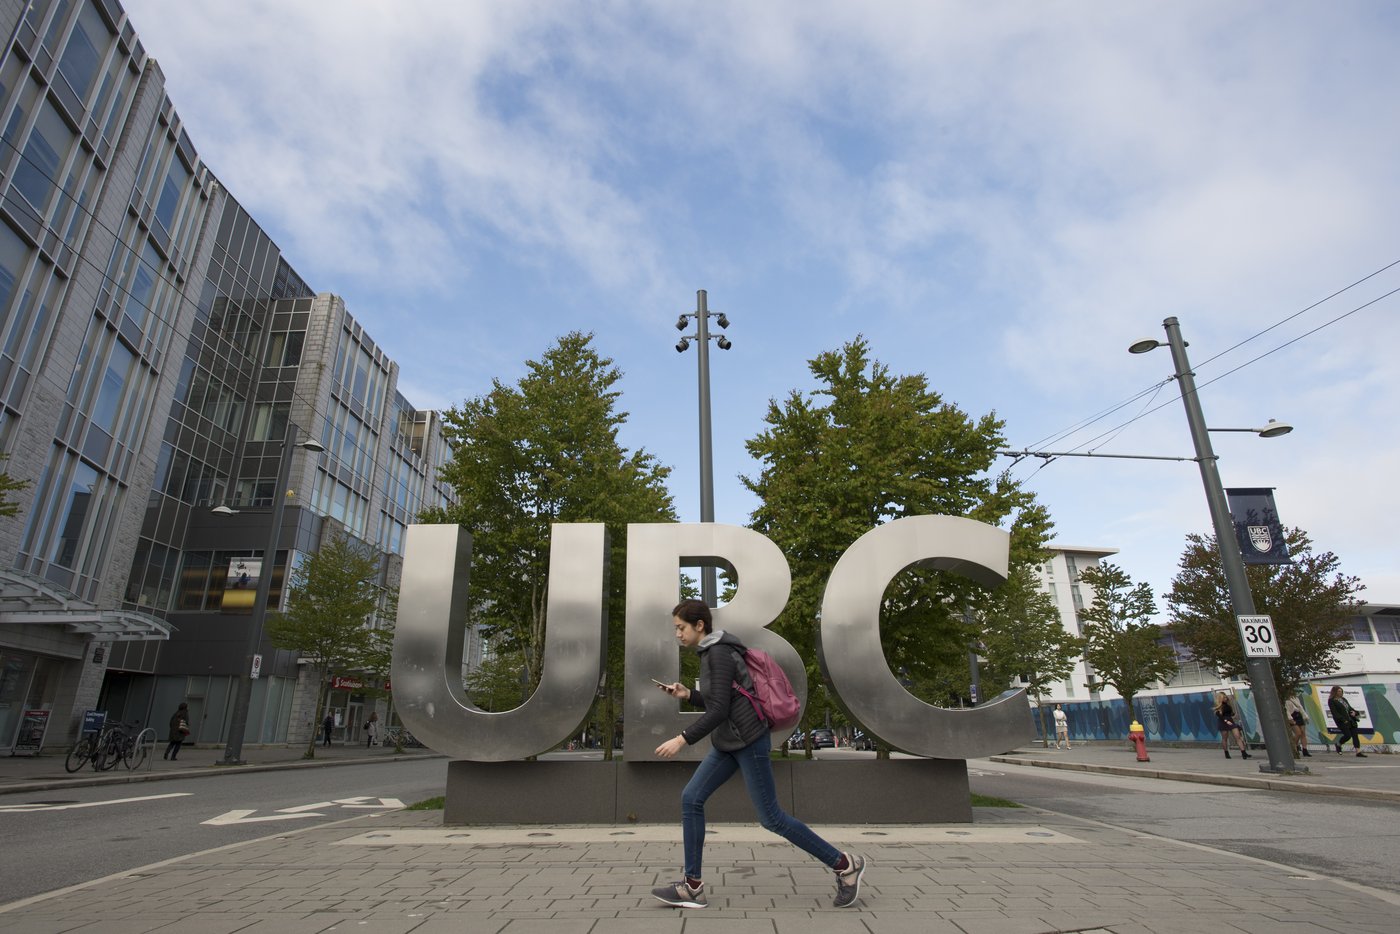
[991,742,1400,802]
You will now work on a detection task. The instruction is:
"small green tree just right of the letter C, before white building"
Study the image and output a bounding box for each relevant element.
[974,566,1085,745]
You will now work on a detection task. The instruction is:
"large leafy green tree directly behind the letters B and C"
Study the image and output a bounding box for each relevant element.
[742,337,1050,756]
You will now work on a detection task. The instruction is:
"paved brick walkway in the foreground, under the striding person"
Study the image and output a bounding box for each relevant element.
[0,808,1400,934]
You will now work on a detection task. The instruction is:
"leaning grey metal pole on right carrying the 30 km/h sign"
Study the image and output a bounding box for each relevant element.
[1130,318,1306,773]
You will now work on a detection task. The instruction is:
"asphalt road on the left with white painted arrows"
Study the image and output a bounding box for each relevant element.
[0,758,447,902]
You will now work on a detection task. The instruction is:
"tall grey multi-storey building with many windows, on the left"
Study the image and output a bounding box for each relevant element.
[0,0,449,752]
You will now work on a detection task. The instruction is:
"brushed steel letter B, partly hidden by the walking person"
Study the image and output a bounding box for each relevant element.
[624,522,806,762]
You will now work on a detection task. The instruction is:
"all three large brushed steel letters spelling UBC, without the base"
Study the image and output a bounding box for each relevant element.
[392,515,1030,762]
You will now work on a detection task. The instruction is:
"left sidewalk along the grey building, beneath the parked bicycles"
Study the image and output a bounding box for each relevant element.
[0,742,438,794]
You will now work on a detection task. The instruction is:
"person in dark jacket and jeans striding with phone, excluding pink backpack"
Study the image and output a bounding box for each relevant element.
[651,599,865,907]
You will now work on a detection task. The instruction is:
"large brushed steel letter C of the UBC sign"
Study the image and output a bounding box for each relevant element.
[817,515,1032,759]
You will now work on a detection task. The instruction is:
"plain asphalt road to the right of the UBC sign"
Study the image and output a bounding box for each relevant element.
[967,760,1400,892]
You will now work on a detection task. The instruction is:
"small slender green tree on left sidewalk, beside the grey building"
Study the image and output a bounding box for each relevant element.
[267,534,379,759]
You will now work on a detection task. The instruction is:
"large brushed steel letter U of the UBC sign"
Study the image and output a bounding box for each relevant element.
[392,522,608,762]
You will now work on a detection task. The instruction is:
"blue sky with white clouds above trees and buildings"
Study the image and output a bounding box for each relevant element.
[125,0,1400,604]
